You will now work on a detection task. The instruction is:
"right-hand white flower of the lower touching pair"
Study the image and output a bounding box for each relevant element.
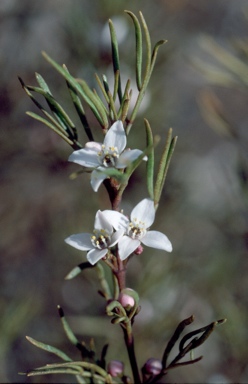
[102,199,172,260]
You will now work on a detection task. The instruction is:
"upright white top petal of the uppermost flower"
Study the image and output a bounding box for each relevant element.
[103,120,127,153]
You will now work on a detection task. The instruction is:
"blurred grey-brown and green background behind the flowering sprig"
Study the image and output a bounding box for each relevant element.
[0,0,248,383]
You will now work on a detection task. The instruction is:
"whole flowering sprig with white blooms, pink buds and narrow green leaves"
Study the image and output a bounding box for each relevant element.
[20,11,224,384]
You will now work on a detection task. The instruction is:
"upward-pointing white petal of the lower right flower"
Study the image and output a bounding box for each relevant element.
[130,199,155,228]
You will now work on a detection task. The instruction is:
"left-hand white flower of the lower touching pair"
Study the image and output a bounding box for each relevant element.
[65,211,124,265]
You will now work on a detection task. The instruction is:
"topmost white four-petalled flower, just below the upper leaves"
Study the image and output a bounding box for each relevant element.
[68,120,146,192]
